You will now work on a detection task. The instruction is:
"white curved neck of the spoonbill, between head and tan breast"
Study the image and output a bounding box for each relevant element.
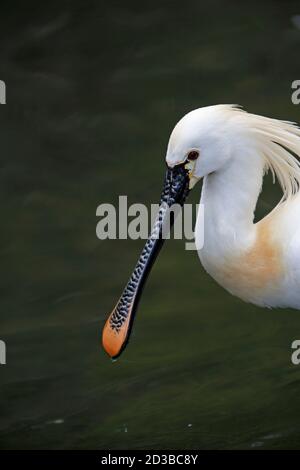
[196,154,264,256]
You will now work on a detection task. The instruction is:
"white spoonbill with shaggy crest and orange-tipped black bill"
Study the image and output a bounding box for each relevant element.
[102,105,300,358]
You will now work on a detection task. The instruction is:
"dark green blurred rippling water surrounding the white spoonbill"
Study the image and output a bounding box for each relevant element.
[0,0,300,449]
